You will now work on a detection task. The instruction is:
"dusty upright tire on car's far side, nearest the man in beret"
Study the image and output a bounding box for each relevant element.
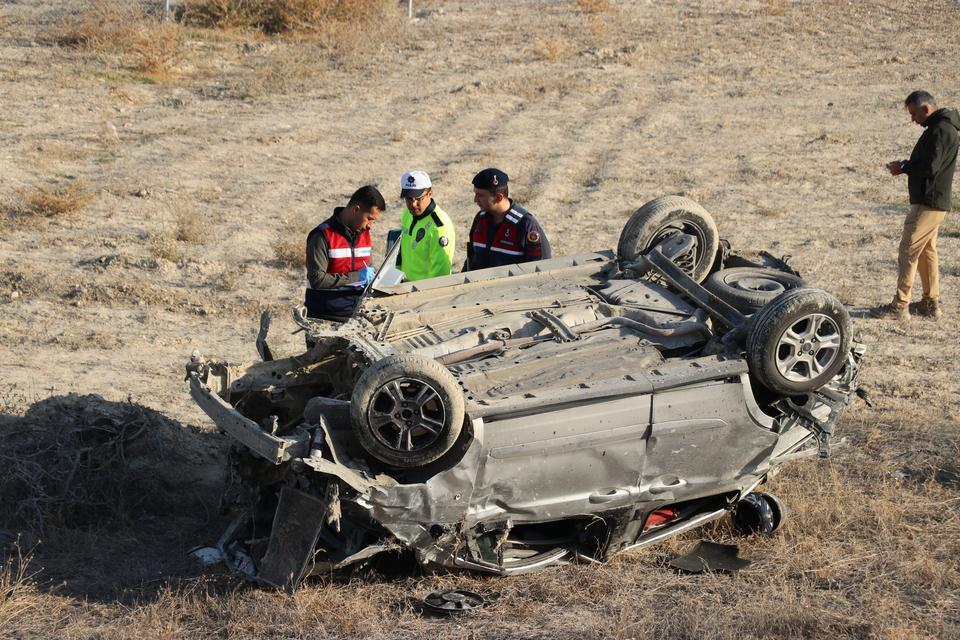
[617,196,720,282]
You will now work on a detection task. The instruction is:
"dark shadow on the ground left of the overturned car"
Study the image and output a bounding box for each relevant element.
[0,394,232,602]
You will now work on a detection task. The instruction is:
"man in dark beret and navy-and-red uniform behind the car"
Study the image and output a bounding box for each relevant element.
[463,168,551,271]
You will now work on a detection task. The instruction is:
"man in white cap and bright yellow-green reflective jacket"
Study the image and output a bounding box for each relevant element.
[397,171,456,280]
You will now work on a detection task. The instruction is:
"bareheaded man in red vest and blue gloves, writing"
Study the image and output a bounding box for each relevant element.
[304,185,386,324]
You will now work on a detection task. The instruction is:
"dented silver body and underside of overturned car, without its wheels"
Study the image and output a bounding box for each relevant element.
[187,226,862,589]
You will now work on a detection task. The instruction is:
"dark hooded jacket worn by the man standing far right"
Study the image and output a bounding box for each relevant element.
[903,109,960,211]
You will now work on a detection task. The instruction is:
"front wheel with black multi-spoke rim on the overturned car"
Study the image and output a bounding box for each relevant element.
[350,355,464,469]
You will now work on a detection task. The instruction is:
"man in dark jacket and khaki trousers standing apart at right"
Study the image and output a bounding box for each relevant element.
[873,91,960,320]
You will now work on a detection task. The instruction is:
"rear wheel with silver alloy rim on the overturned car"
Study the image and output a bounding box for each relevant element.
[747,289,850,395]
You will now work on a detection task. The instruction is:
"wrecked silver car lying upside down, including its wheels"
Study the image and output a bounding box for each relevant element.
[187,196,863,589]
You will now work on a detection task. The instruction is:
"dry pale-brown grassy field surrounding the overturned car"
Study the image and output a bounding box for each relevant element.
[0,0,960,640]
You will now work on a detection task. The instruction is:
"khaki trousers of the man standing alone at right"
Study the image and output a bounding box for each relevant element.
[893,204,946,307]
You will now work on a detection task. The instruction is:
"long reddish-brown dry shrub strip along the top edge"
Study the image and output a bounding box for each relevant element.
[185,0,392,33]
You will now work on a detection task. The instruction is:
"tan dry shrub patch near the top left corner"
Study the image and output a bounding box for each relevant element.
[53,0,185,79]
